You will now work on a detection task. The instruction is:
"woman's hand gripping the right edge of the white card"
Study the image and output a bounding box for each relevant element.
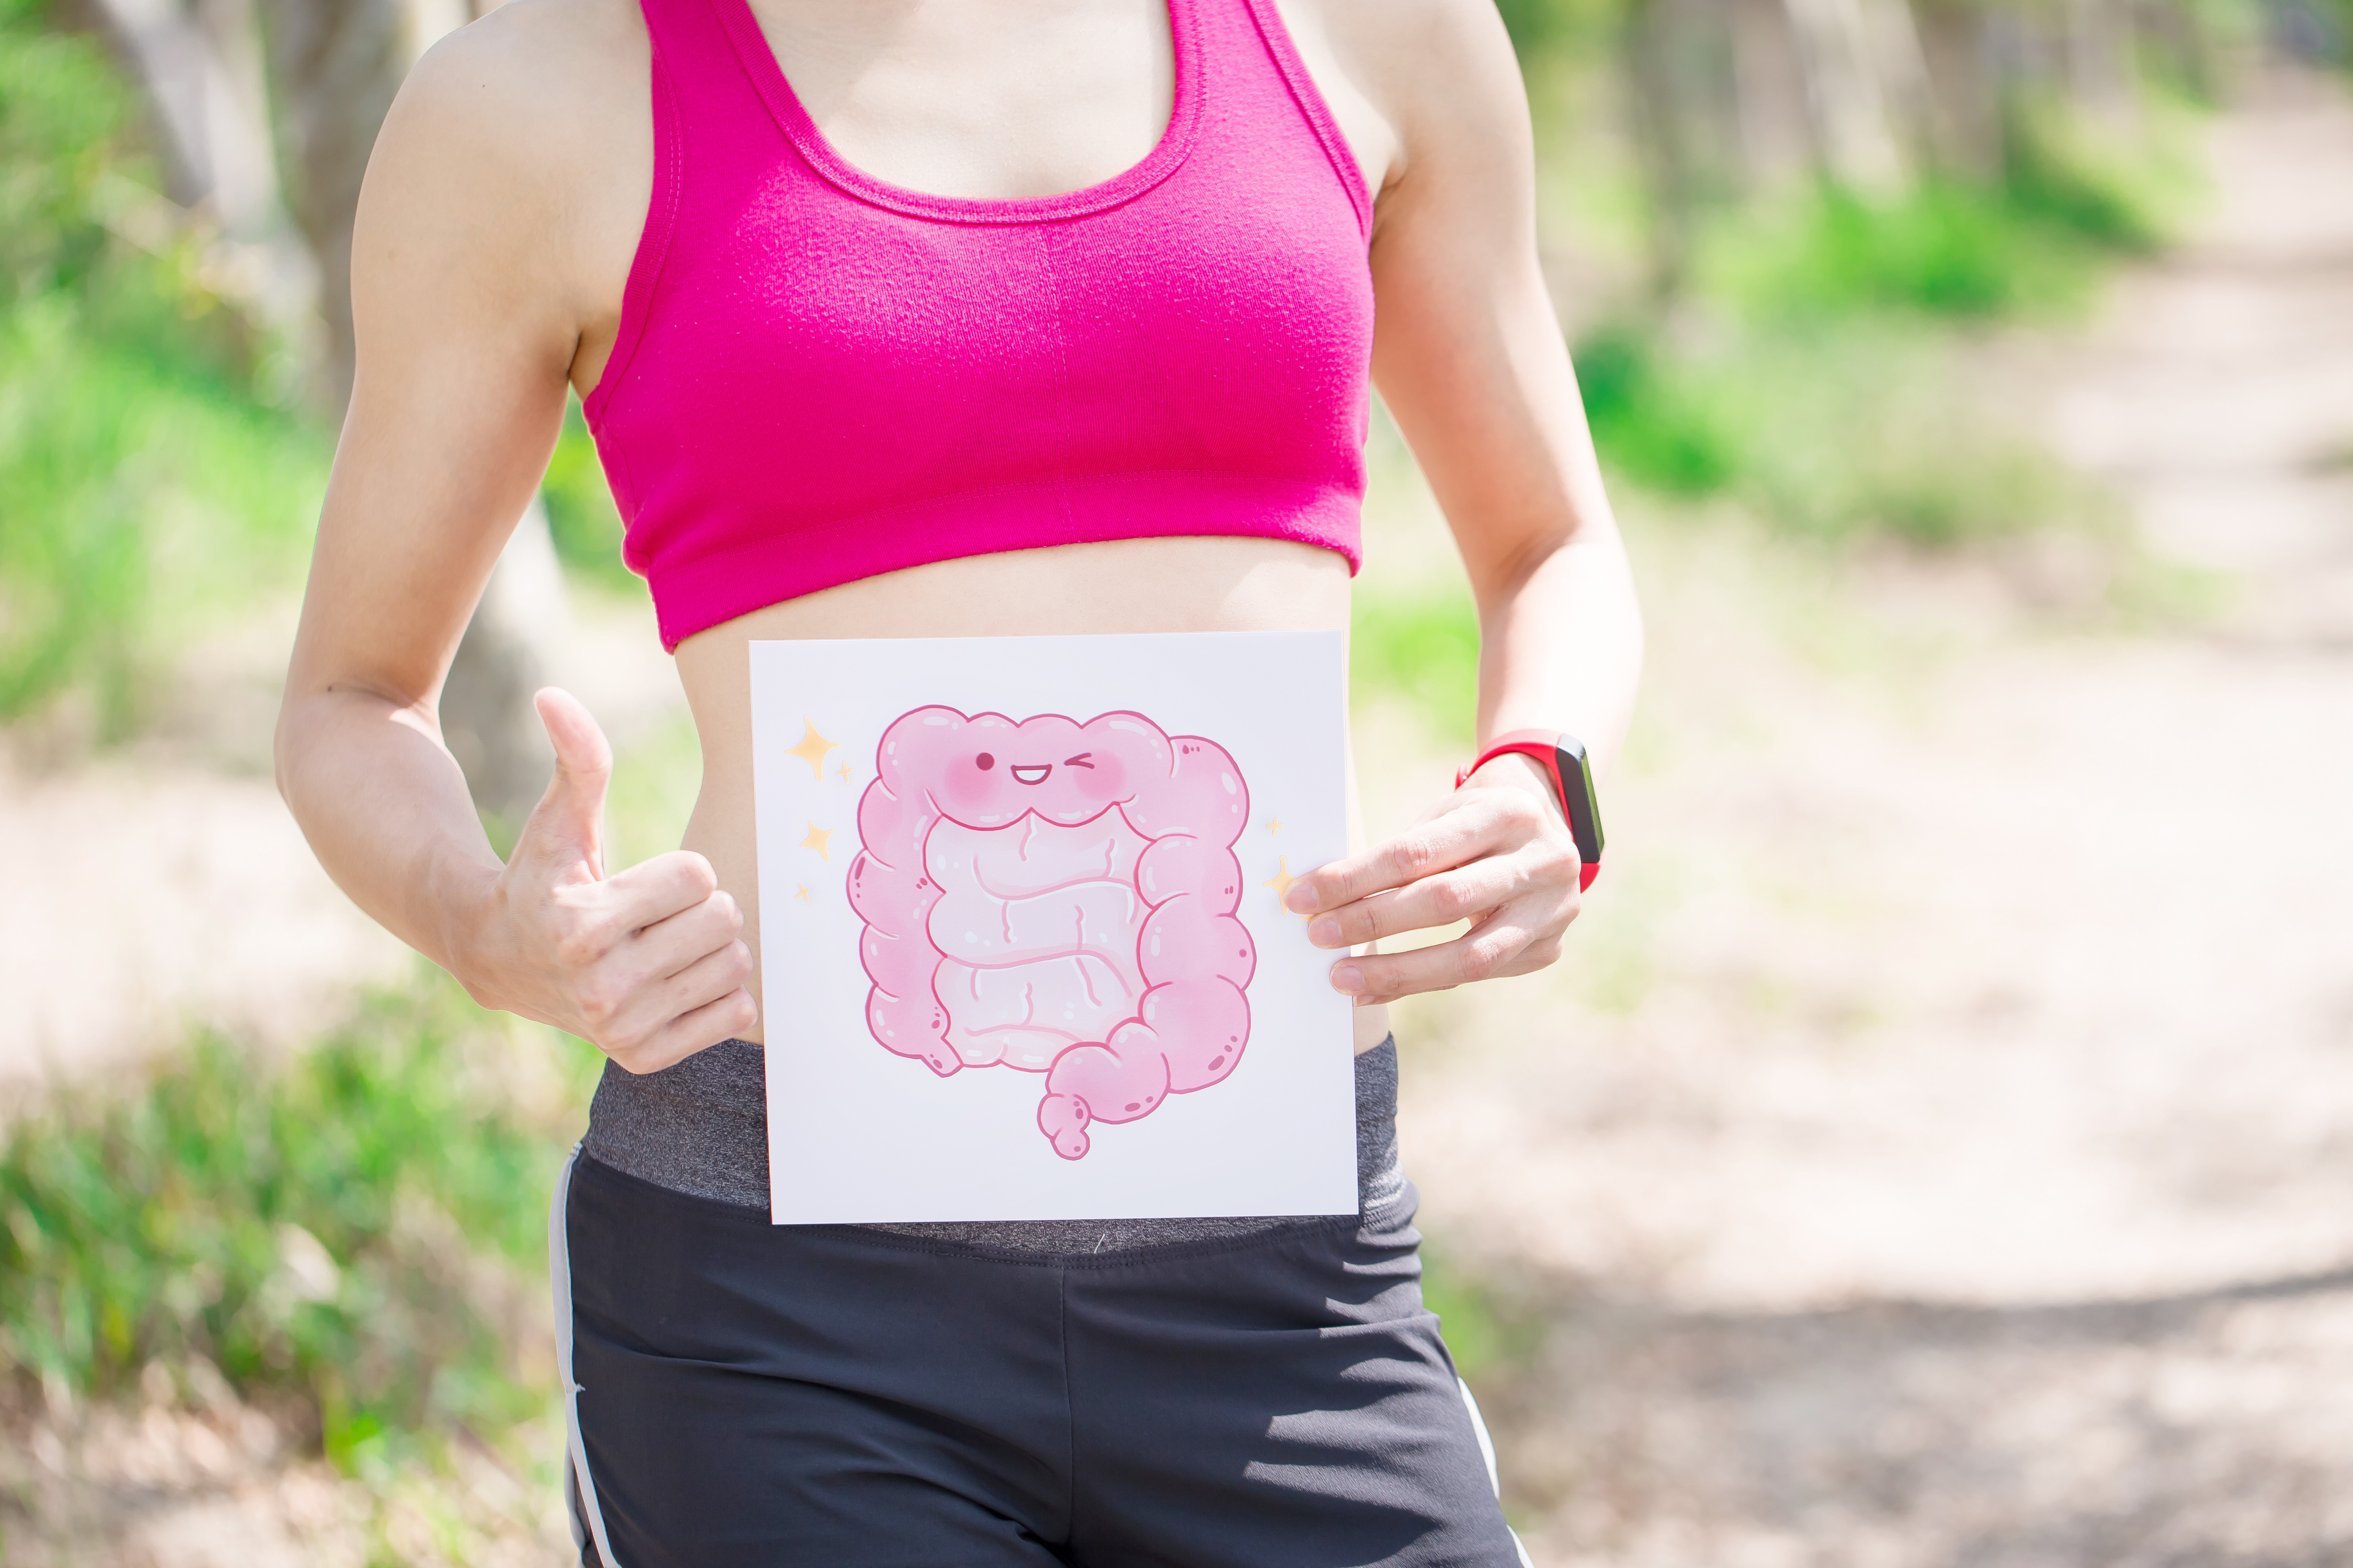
[1283,753,1579,1006]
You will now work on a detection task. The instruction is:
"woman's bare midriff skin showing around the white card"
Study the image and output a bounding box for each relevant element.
[678,538,1388,1051]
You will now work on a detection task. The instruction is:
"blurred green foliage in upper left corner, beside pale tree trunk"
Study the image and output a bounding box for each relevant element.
[0,5,327,736]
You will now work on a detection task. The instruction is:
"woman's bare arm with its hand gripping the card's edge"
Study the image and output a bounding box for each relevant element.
[1289,0,1642,1004]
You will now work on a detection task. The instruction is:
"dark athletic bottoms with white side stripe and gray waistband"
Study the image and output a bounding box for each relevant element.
[551,1041,1527,1568]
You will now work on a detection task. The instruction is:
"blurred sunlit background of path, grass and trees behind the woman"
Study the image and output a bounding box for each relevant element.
[0,0,2353,1568]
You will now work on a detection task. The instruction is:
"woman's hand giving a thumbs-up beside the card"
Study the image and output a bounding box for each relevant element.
[461,686,760,1072]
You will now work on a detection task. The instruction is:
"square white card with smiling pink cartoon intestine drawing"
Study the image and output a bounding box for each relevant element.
[750,632,1357,1225]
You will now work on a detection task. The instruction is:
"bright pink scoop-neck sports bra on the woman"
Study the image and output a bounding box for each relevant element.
[586,0,1372,649]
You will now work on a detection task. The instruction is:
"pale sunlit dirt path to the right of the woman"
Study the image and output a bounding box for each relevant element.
[1405,67,2353,1568]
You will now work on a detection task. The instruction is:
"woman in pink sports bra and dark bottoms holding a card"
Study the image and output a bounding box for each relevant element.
[277,0,1640,1568]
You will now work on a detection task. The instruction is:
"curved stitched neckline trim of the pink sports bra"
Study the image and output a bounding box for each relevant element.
[711,0,1200,223]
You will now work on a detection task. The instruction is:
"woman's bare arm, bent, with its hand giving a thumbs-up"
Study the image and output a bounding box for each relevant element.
[277,5,753,1072]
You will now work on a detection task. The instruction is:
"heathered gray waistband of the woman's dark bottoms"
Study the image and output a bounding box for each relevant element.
[584,1039,1405,1253]
